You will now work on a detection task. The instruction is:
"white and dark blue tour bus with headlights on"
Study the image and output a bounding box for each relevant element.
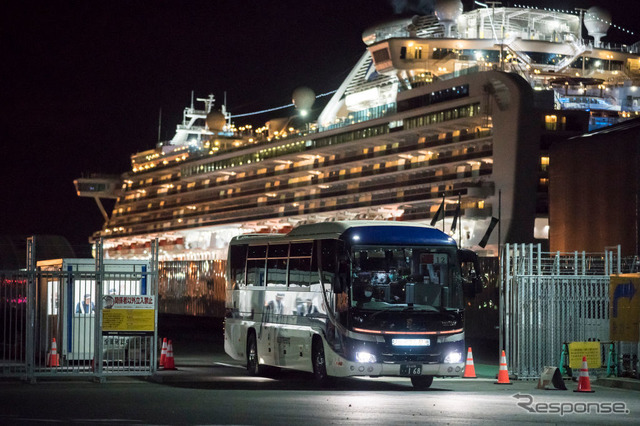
[224,221,481,389]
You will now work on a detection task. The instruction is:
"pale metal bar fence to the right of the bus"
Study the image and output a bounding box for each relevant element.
[500,244,636,379]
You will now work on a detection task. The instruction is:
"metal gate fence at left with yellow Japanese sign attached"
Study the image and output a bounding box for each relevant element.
[0,238,158,381]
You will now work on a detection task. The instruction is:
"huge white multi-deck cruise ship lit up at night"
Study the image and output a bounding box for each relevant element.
[75,0,640,311]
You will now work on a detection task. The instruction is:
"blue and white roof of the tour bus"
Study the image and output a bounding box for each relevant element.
[232,220,456,246]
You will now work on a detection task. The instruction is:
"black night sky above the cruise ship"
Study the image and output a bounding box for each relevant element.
[0,0,640,251]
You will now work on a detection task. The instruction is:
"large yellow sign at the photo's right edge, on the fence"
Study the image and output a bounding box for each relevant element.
[609,274,640,342]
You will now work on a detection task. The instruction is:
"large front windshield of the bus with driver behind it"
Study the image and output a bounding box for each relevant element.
[350,247,462,311]
